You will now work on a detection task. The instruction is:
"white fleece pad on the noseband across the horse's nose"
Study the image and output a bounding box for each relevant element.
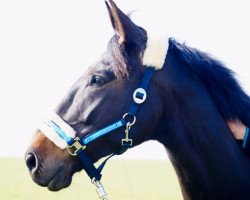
[38,112,76,149]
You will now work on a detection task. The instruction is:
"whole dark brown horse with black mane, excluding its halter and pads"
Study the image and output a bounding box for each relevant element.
[25,0,250,200]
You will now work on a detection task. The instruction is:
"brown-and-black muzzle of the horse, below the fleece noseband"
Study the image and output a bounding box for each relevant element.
[25,131,78,191]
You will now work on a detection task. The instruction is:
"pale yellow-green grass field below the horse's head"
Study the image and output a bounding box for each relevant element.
[0,158,182,200]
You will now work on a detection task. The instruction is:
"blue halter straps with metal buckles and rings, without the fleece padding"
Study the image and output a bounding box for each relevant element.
[41,67,155,200]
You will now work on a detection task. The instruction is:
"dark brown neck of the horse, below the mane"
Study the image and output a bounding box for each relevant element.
[152,50,250,199]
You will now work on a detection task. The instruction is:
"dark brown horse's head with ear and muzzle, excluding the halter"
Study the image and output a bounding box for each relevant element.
[26,0,162,190]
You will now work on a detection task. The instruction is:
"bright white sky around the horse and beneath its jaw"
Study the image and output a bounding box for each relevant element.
[0,0,250,159]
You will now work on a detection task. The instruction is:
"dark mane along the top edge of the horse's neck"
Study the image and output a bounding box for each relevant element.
[169,38,250,126]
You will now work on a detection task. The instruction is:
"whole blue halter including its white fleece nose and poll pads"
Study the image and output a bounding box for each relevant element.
[39,32,168,200]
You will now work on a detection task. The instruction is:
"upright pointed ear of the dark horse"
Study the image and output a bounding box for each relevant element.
[105,0,147,47]
